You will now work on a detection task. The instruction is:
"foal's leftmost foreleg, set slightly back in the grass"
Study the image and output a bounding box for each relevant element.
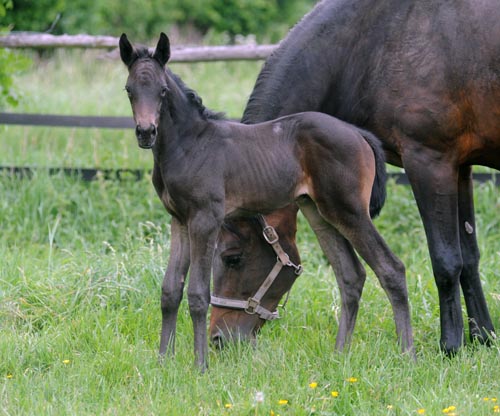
[160,218,189,356]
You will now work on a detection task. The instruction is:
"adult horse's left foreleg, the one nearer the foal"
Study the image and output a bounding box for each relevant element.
[403,156,465,354]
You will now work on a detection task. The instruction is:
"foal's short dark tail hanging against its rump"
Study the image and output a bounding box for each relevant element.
[359,129,387,218]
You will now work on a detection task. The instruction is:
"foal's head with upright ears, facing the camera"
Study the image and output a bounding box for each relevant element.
[120,33,170,149]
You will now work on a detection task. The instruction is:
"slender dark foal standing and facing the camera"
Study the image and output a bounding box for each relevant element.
[120,33,413,368]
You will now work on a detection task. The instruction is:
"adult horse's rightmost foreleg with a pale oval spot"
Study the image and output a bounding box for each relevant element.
[458,166,494,342]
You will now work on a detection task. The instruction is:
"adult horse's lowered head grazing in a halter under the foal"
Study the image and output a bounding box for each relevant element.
[210,205,300,347]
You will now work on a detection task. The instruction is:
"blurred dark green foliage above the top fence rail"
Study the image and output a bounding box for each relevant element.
[0,0,315,41]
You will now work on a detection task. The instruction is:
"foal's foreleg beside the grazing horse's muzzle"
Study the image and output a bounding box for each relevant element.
[188,213,222,371]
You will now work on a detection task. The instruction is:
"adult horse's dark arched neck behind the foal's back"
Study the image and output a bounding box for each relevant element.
[242,0,386,124]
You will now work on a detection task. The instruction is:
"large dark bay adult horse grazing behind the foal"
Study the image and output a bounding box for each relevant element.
[211,0,500,353]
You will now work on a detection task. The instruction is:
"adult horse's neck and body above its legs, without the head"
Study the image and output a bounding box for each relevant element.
[243,0,500,166]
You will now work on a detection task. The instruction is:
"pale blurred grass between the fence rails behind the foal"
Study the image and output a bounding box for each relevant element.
[0,50,261,168]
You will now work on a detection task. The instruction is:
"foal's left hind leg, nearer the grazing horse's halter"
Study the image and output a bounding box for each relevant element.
[297,198,366,351]
